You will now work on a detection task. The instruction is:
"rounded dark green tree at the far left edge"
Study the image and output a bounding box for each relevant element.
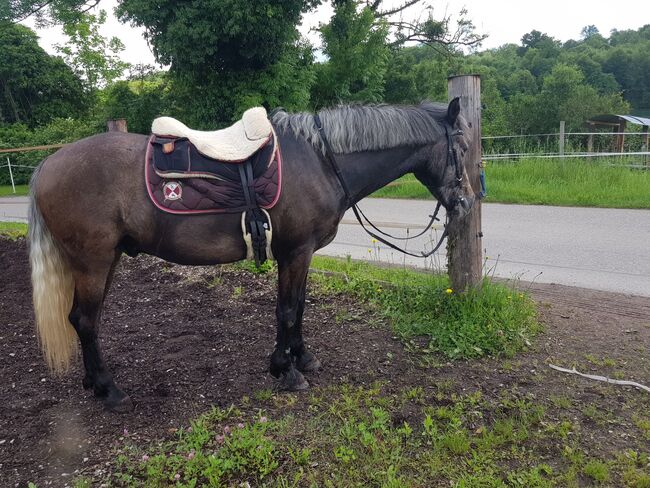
[0,22,86,127]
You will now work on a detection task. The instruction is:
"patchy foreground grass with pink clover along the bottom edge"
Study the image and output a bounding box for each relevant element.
[93,384,649,488]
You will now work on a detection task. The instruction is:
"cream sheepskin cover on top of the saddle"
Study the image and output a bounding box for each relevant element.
[151,107,273,163]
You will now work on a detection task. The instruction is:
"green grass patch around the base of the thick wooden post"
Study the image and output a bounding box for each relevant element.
[311,256,540,358]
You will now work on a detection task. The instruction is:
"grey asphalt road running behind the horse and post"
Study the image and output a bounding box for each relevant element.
[0,197,650,297]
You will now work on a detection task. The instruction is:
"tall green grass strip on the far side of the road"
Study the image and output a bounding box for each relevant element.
[373,159,650,208]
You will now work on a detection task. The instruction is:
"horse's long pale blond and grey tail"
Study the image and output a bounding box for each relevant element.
[29,163,77,373]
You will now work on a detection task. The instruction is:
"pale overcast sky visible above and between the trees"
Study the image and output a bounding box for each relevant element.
[26,0,650,64]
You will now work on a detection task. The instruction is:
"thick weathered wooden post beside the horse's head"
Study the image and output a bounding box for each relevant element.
[447,75,483,292]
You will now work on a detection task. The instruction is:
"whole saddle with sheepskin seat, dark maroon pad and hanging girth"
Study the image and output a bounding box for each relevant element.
[145,107,282,265]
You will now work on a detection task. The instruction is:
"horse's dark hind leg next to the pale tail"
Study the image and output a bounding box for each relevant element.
[70,256,133,411]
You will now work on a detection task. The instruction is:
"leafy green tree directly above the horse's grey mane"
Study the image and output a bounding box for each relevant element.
[312,0,485,107]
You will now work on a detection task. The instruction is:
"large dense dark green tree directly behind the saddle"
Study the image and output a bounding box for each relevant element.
[113,0,320,128]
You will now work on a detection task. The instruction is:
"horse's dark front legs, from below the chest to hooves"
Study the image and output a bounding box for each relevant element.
[271,252,318,390]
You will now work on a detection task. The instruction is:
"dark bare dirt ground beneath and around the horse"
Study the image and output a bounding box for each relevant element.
[0,239,650,487]
